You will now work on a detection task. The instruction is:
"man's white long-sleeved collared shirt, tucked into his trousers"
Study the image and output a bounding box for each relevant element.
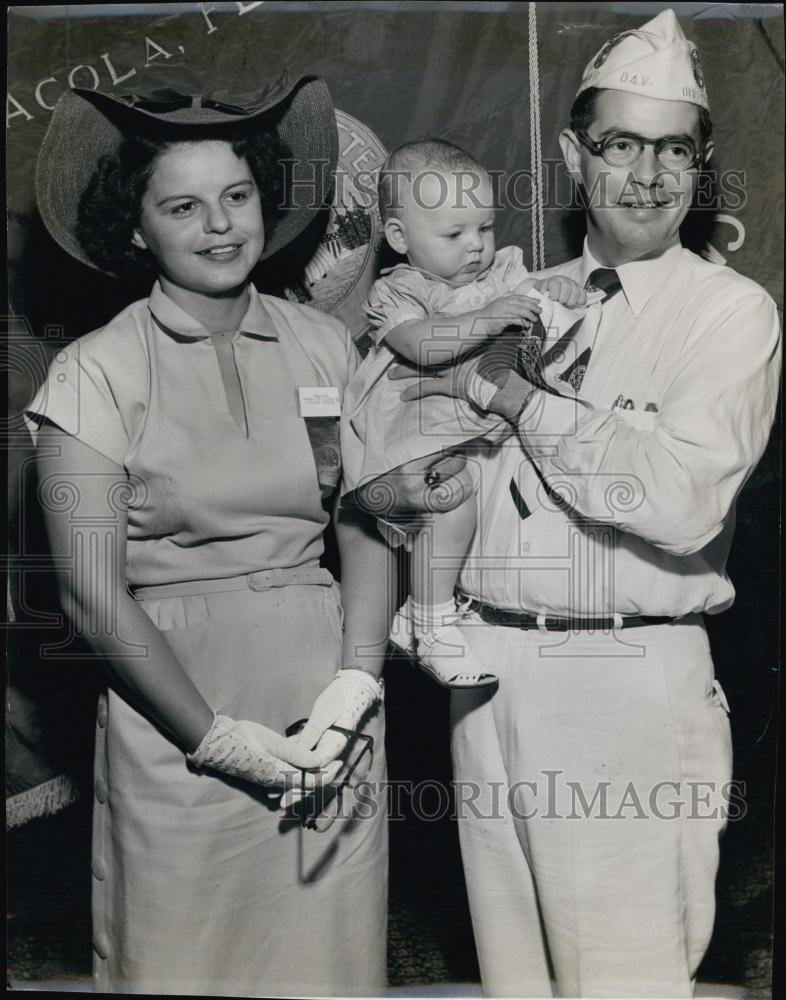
[459,243,780,617]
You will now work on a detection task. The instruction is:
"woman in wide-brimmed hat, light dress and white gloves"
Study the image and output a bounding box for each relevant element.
[29,77,387,996]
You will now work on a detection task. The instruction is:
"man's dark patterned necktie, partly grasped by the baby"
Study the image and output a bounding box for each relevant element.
[510,267,622,519]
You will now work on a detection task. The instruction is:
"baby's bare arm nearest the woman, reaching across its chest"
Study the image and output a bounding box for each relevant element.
[385,294,544,366]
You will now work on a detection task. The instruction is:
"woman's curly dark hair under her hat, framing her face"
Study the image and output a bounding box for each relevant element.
[76,127,291,278]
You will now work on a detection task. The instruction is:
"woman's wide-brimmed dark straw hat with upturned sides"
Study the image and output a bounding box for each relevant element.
[36,74,338,270]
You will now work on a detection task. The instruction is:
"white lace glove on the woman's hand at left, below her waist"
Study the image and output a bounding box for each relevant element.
[187,714,341,789]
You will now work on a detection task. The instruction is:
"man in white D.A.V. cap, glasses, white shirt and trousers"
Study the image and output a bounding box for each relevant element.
[404,10,779,997]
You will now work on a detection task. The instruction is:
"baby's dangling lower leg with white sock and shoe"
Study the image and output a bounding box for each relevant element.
[411,482,497,687]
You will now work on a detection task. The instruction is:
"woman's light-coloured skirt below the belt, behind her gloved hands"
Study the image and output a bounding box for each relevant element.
[93,567,387,997]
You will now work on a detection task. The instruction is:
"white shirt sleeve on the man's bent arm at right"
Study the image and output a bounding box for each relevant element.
[518,286,780,555]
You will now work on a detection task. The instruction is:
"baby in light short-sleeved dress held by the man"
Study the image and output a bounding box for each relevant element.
[341,139,586,688]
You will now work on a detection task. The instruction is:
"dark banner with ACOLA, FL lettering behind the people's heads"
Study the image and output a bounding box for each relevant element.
[7,2,783,310]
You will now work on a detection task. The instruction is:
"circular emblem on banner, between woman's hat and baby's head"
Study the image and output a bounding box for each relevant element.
[285,108,387,338]
